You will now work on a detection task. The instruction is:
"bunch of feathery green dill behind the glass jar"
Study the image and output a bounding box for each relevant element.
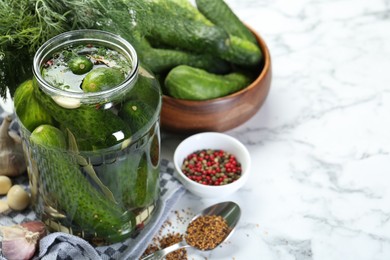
[0,0,200,98]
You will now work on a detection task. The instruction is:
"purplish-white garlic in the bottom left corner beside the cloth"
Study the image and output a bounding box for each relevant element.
[0,221,46,260]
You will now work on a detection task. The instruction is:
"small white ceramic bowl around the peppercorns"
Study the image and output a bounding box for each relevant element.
[173,132,251,198]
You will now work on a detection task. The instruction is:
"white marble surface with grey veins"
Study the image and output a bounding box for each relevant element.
[162,0,390,260]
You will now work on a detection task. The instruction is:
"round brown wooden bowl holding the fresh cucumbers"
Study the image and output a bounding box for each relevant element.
[161,30,272,133]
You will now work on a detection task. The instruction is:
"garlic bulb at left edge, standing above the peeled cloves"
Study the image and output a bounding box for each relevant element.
[0,116,26,176]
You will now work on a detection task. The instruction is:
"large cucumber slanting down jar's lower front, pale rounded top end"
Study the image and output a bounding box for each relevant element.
[30,125,135,241]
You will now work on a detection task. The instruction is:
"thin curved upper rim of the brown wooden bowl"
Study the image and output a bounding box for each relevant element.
[162,26,271,105]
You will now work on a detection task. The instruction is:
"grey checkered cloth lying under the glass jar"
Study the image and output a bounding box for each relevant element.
[0,106,185,260]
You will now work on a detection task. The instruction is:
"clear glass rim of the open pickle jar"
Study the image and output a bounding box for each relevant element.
[33,29,139,104]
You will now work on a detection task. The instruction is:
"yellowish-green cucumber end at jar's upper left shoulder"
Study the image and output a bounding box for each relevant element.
[14,80,55,132]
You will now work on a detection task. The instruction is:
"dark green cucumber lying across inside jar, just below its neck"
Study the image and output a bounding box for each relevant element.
[33,80,131,151]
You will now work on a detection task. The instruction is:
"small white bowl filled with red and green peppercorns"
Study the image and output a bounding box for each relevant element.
[173,132,251,198]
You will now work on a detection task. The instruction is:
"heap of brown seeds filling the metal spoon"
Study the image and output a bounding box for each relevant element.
[185,215,230,250]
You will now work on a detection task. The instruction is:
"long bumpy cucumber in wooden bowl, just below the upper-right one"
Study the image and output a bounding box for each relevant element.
[134,0,261,66]
